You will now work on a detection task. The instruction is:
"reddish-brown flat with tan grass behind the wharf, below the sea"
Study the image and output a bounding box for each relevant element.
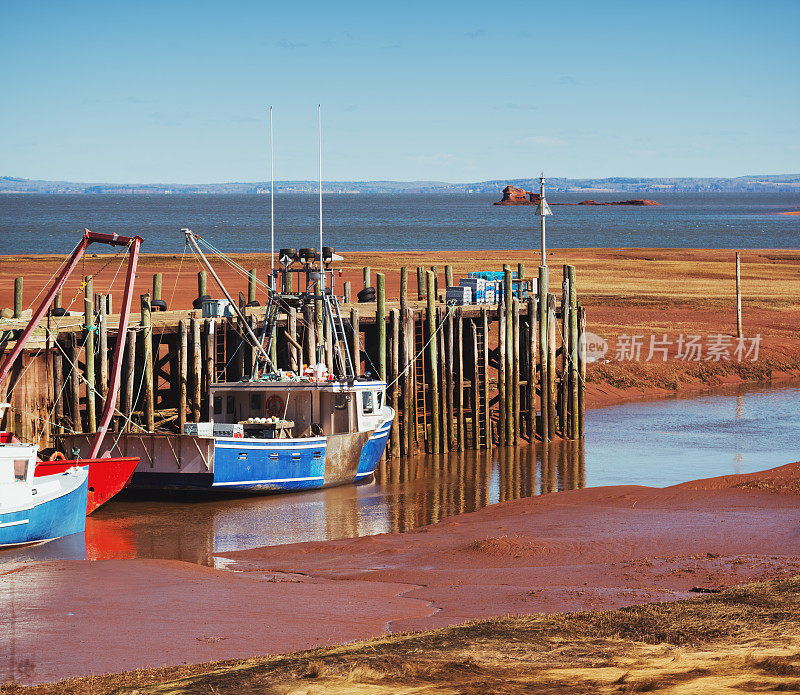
[0,243,800,406]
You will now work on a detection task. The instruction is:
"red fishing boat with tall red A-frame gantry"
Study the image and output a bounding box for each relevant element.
[0,229,142,514]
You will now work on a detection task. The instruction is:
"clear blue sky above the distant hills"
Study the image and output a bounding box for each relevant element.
[0,0,800,183]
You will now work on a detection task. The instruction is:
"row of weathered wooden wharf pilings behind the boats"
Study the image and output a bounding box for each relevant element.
[21,265,586,457]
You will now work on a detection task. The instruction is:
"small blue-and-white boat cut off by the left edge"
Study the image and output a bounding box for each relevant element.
[0,404,89,547]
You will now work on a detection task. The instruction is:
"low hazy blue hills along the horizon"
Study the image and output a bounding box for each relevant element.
[0,174,800,195]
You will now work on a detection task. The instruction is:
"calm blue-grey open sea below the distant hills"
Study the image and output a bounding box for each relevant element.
[0,193,800,254]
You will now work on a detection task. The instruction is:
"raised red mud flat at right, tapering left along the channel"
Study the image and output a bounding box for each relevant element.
[220,463,800,631]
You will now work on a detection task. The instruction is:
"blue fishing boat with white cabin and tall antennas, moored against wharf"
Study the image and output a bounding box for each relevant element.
[58,109,395,493]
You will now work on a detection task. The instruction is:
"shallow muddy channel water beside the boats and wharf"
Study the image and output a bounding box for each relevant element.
[0,383,800,566]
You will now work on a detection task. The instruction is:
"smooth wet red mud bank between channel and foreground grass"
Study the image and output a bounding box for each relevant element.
[0,463,800,683]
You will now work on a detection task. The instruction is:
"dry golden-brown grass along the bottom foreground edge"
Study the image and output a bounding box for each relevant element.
[7,578,800,695]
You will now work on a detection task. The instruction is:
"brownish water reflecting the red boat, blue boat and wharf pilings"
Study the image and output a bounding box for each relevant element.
[75,442,585,567]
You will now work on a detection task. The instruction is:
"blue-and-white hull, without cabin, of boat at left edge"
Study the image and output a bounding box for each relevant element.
[0,468,89,547]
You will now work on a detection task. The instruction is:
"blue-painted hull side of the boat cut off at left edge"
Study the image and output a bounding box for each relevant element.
[0,471,88,546]
